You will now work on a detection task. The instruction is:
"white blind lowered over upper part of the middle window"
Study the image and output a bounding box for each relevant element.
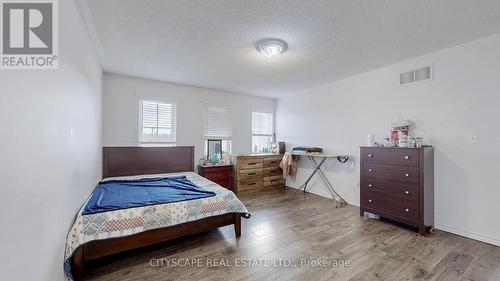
[205,107,231,140]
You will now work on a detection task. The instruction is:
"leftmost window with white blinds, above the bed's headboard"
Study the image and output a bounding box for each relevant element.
[139,100,177,143]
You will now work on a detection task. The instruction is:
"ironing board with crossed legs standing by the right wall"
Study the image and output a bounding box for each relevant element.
[292,152,349,207]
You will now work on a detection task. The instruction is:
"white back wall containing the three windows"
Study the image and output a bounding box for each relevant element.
[104,74,275,162]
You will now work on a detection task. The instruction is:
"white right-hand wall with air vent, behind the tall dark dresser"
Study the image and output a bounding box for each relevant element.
[276,35,500,245]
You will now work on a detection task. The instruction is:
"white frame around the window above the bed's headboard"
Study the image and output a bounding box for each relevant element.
[137,97,178,143]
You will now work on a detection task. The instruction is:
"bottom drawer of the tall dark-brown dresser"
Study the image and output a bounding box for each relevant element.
[361,192,419,222]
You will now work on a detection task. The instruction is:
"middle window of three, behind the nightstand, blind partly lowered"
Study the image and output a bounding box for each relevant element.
[205,107,231,156]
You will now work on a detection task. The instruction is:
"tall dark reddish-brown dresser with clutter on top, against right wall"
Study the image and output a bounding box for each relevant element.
[360,147,434,235]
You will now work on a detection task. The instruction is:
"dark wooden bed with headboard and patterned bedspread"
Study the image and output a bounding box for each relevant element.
[64,146,250,280]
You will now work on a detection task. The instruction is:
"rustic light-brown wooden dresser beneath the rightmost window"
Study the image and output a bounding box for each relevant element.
[232,154,284,192]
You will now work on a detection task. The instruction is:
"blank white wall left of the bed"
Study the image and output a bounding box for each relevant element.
[0,0,102,281]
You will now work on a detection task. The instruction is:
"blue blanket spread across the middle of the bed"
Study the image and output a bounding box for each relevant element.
[82,176,215,215]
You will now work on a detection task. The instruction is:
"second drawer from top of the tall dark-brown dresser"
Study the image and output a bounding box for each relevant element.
[361,164,420,185]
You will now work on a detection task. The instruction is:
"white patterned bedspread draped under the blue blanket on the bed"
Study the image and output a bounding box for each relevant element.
[64,172,250,278]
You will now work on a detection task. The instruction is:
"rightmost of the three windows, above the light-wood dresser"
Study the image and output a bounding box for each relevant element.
[252,112,274,153]
